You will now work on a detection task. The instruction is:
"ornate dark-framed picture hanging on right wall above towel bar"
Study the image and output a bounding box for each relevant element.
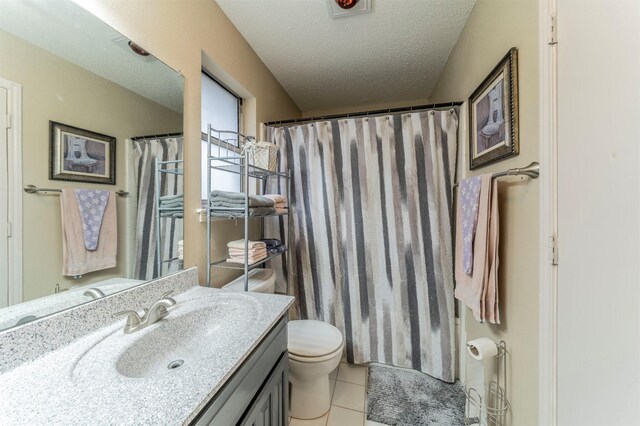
[468,47,520,170]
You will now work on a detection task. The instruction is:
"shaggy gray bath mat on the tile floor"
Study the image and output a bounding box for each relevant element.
[367,364,465,426]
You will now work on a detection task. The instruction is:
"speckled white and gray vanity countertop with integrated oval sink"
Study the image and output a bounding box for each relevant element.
[0,287,293,425]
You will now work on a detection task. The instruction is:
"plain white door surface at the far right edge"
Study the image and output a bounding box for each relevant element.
[558,0,640,425]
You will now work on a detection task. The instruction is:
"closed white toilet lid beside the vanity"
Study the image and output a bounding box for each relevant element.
[287,320,342,357]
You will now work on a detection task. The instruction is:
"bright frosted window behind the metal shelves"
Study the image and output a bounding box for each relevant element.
[201,71,242,200]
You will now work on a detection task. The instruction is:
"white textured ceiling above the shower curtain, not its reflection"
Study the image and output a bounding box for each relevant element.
[216,0,475,111]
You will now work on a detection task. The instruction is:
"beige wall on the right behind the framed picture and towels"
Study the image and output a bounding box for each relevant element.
[430,0,539,425]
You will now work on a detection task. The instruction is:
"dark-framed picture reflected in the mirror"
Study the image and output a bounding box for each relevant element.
[49,121,116,185]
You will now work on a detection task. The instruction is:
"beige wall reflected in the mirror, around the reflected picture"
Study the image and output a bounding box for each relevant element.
[0,31,182,301]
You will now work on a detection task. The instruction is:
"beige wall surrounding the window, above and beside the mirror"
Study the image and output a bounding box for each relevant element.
[78,0,300,288]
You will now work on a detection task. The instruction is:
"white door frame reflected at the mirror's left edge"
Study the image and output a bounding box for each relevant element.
[0,78,22,306]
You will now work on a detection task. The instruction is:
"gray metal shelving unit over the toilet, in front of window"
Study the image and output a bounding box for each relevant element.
[203,124,290,294]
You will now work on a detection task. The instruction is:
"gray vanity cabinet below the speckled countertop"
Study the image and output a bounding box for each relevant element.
[191,316,289,426]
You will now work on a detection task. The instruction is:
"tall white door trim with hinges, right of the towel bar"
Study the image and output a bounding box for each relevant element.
[538,0,561,426]
